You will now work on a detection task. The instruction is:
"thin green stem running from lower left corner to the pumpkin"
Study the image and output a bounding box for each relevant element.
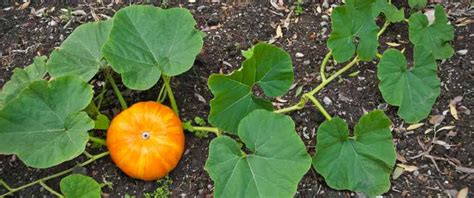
[0,151,109,197]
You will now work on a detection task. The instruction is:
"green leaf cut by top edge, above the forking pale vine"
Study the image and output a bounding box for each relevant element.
[327,0,379,62]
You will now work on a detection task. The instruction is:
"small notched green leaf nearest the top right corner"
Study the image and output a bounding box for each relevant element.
[408,5,454,59]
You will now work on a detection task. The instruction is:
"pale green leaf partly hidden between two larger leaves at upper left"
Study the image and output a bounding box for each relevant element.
[47,20,112,81]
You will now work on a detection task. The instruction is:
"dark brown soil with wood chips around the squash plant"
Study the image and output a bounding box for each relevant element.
[0,0,474,197]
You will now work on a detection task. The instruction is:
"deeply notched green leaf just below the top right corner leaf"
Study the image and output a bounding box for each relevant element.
[377,46,440,123]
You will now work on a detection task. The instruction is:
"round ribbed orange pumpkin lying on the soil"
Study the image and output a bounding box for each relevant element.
[107,102,184,181]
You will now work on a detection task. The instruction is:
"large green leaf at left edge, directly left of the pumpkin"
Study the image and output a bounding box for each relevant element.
[0,76,94,168]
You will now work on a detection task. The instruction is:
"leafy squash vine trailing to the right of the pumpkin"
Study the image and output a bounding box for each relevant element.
[185,0,453,197]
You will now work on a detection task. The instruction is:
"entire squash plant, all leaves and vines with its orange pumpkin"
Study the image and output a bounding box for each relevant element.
[0,0,453,197]
